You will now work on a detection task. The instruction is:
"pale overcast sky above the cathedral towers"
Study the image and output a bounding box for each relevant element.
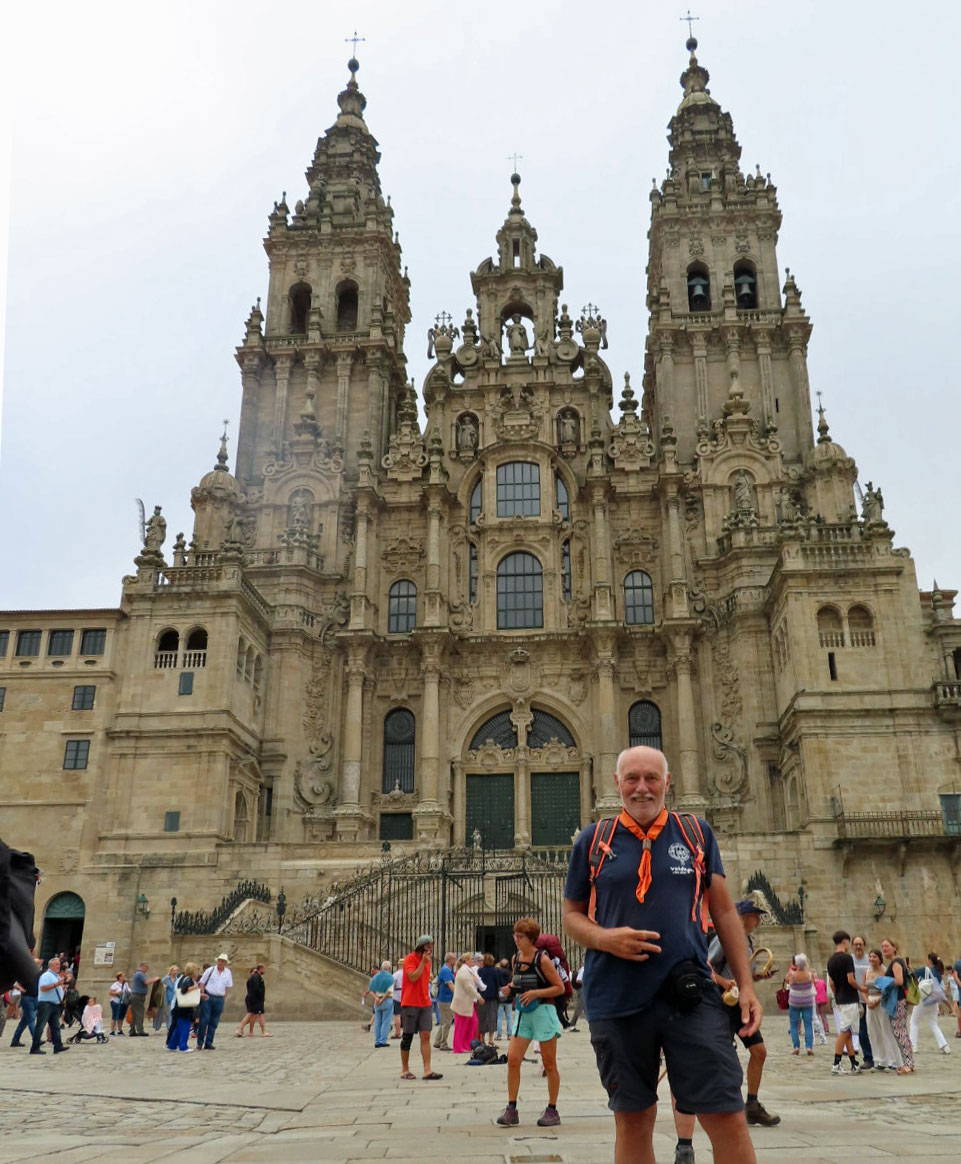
[0,0,961,609]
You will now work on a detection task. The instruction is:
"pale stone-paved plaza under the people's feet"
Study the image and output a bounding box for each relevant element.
[0,1014,961,1164]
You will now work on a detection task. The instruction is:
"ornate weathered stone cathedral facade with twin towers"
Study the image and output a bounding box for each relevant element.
[0,42,961,974]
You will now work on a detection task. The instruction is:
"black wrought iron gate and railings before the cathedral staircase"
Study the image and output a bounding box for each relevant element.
[284,849,582,974]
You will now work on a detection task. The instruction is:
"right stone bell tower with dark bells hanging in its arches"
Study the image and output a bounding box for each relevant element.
[645,37,813,463]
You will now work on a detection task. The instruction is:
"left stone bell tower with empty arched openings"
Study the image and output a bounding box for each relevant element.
[237,59,410,489]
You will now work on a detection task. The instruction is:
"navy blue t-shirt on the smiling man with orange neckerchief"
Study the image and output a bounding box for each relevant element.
[564,814,724,1022]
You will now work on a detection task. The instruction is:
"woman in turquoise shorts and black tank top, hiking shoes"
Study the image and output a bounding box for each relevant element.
[497,917,564,1128]
